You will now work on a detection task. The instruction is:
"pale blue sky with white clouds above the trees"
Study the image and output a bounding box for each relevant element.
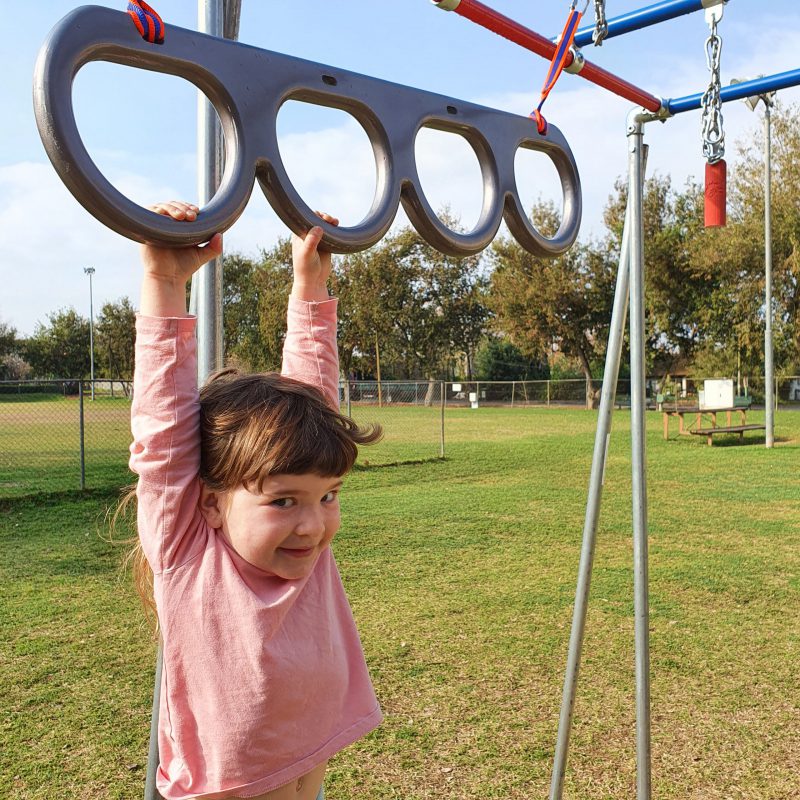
[0,0,800,335]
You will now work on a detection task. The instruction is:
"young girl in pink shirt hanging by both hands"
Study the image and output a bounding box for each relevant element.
[130,202,381,800]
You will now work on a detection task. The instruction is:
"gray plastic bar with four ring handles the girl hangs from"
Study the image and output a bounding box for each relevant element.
[34,6,581,256]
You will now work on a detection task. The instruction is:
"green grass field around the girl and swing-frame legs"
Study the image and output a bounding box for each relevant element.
[0,408,800,800]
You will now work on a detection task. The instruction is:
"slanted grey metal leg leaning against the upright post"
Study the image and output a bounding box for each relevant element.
[548,141,631,800]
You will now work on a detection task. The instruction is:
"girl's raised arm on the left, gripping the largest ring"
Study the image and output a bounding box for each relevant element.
[130,202,222,572]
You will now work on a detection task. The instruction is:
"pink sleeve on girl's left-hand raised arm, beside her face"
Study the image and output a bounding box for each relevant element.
[129,315,203,573]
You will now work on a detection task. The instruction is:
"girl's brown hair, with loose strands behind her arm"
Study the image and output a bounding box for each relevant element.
[122,368,382,620]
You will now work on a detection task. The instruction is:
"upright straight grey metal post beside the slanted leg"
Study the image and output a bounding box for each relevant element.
[628,113,651,800]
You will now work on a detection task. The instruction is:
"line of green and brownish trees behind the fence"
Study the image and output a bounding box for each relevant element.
[0,106,800,394]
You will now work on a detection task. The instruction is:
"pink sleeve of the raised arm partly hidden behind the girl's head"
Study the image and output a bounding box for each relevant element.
[281,297,339,409]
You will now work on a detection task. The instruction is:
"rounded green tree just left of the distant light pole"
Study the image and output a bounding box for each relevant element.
[24,308,90,378]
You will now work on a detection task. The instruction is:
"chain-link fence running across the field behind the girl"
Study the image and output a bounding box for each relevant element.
[0,376,800,498]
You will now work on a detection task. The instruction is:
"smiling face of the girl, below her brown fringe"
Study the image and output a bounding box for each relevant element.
[200,473,342,580]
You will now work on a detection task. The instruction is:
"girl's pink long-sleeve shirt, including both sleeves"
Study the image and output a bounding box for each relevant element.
[130,299,381,800]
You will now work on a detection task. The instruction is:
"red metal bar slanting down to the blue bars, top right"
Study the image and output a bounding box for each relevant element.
[434,0,661,112]
